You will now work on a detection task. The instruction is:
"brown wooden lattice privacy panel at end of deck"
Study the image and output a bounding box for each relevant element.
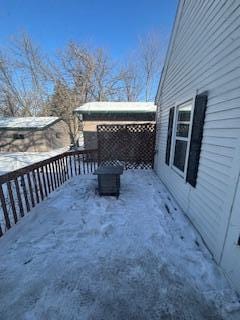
[97,123,156,169]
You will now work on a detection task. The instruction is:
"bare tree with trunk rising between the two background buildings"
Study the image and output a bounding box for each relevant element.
[44,42,95,145]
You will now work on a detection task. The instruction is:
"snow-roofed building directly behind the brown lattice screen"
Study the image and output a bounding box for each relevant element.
[75,102,156,149]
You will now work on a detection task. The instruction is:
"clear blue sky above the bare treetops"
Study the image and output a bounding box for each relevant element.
[0,0,177,58]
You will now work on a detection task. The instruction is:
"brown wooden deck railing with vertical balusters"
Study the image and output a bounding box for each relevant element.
[0,150,97,237]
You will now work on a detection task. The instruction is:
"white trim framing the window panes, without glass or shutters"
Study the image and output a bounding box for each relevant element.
[170,95,196,181]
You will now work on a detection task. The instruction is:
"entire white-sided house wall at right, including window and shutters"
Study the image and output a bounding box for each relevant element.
[155,0,240,292]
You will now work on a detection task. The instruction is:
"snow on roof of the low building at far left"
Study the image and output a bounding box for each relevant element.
[0,117,60,130]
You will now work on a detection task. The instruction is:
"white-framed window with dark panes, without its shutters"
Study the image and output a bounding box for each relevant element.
[172,101,192,176]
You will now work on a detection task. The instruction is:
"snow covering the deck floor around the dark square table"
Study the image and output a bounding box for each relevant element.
[0,171,240,320]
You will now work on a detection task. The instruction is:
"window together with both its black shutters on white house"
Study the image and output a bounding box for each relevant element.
[165,91,208,188]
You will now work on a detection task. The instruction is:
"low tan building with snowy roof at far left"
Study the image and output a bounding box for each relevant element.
[0,117,70,152]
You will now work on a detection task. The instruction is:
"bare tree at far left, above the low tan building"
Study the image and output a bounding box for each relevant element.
[0,34,50,116]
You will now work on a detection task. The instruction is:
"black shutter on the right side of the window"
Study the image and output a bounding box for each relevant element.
[186,92,208,188]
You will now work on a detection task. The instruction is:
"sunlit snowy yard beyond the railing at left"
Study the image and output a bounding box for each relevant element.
[0,148,66,175]
